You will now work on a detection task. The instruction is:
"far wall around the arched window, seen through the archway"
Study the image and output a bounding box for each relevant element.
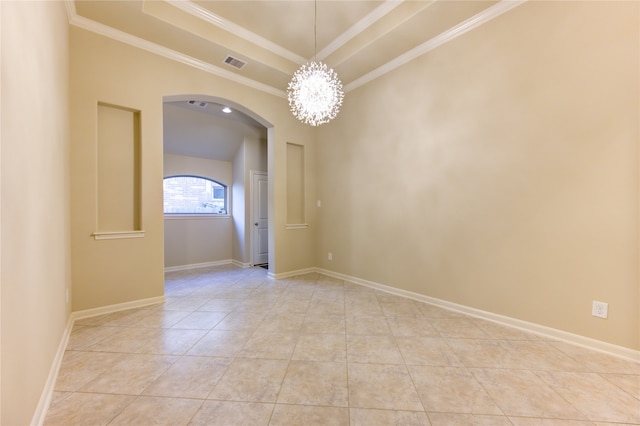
[164,154,233,268]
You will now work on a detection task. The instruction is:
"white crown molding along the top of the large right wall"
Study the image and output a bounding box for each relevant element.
[344,0,527,92]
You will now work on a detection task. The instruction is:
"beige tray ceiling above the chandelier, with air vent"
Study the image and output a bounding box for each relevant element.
[66,0,523,161]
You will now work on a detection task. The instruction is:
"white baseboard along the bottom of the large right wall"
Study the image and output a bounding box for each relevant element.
[318,268,640,362]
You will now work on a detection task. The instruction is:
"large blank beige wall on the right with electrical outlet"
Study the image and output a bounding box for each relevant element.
[317,2,640,350]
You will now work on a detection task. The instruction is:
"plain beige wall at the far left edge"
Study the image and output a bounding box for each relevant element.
[0,1,71,425]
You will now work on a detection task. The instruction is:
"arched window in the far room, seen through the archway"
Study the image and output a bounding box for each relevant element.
[163,176,227,214]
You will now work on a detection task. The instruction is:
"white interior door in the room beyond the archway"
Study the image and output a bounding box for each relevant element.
[251,171,269,265]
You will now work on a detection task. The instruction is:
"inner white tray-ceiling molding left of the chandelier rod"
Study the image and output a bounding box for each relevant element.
[165,0,307,65]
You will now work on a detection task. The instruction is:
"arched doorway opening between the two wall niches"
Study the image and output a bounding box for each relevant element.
[163,95,275,271]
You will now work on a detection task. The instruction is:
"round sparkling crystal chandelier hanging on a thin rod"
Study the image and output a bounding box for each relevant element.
[287,2,344,126]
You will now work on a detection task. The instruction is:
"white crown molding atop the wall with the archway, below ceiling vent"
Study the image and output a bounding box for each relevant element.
[66,11,287,98]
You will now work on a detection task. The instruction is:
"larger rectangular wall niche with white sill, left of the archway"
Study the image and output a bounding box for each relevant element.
[97,103,141,234]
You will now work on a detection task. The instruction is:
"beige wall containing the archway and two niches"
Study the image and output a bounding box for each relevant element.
[70,27,315,310]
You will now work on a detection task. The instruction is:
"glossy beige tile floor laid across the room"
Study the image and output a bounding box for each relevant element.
[45,266,640,426]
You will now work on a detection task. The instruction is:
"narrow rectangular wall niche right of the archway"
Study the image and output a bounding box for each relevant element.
[287,143,306,225]
